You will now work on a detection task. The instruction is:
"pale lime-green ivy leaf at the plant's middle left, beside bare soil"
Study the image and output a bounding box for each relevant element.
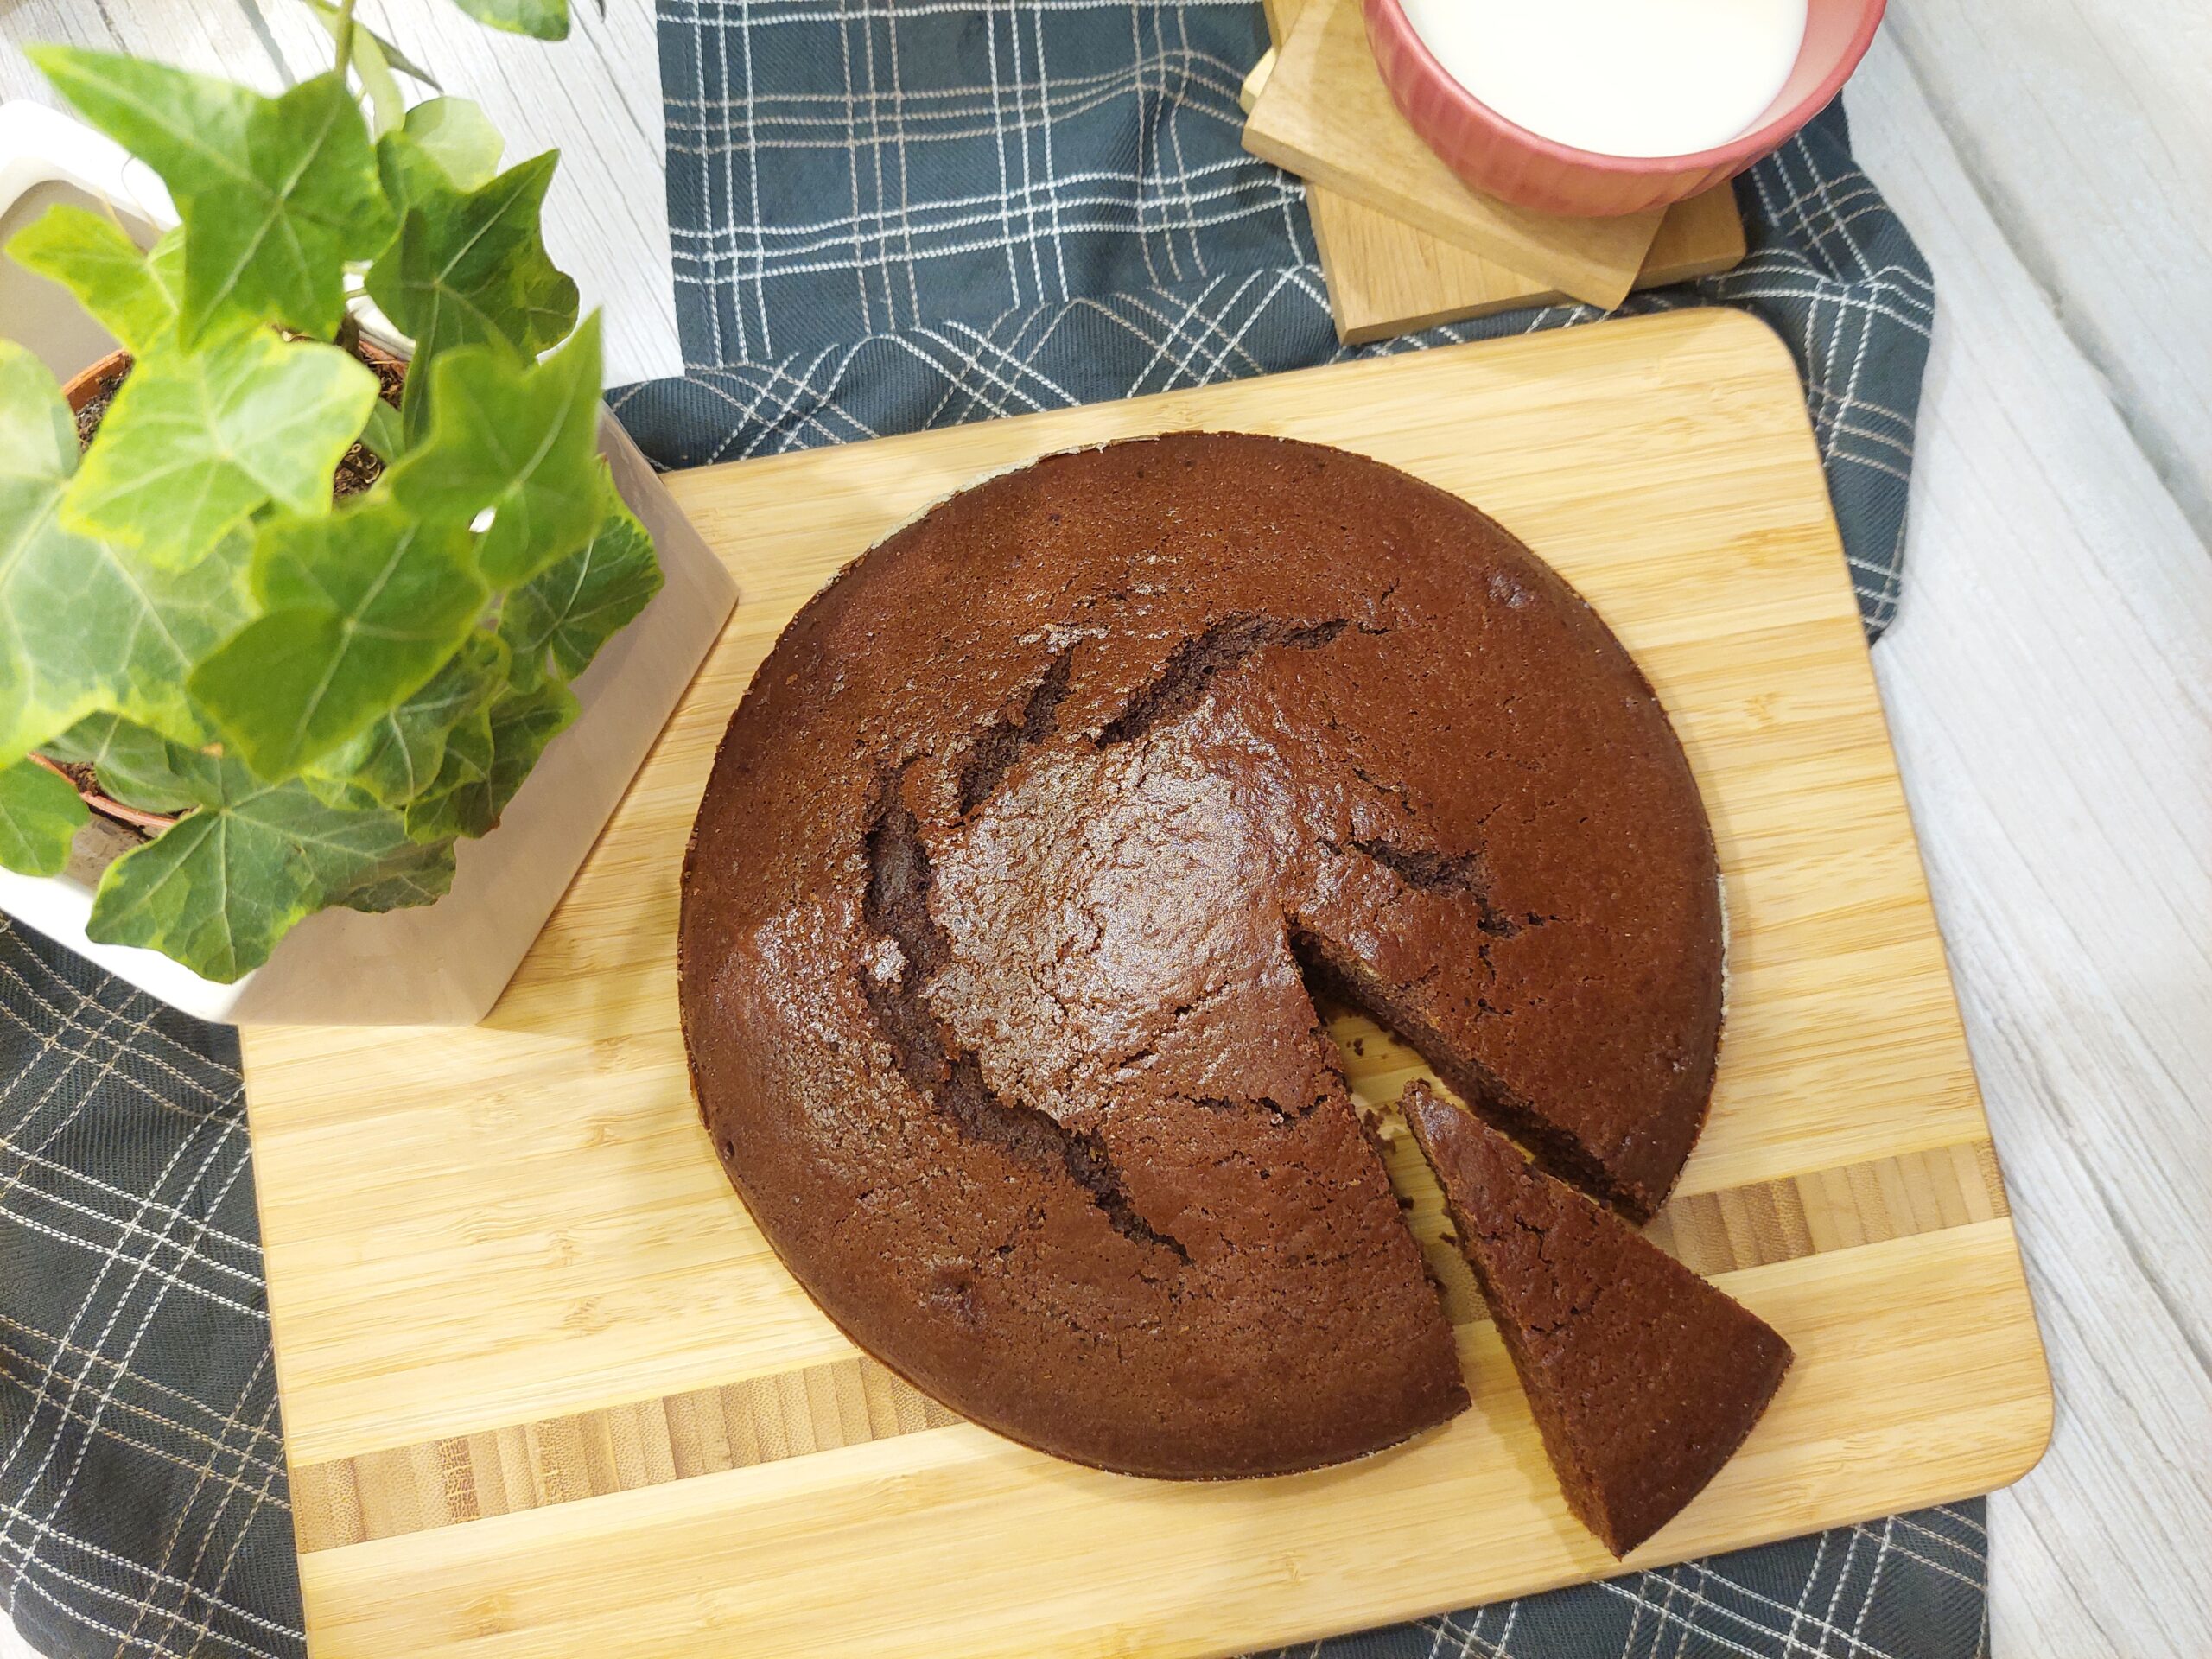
[62,327,376,566]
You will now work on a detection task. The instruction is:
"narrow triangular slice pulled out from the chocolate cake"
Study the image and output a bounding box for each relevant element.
[1400,1082,1789,1555]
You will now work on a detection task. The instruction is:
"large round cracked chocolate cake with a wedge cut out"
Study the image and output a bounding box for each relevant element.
[679,434,1721,1476]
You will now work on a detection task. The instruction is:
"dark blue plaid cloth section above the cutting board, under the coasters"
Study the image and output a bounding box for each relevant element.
[615,0,1936,632]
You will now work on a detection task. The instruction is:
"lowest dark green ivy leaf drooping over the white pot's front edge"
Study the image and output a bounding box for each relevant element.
[84,757,454,984]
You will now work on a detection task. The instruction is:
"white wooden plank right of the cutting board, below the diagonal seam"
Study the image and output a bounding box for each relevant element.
[1852,42,2212,1659]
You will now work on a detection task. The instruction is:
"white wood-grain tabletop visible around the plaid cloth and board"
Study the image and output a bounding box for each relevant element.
[0,0,2212,1659]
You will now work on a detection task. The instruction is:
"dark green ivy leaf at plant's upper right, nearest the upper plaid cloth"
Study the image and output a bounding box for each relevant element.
[370,149,575,380]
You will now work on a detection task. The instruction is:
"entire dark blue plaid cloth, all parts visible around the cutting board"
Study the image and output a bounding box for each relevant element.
[0,0,1955,1659]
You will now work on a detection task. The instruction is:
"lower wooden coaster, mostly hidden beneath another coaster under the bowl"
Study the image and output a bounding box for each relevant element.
[1236,0,1745,345]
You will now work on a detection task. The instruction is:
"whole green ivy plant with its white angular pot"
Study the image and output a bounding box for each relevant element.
[0,0,734,1020]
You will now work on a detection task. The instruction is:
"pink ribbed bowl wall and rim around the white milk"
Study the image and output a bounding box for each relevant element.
[1363,0,1885,219]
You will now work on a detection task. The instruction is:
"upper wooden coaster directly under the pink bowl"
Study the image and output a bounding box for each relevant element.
[1245,0,1663,309]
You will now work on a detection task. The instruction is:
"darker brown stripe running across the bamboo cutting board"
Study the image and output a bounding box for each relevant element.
[292,1139,2011,1555]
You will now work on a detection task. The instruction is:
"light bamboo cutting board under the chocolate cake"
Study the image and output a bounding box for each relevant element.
[233,309,2050,1659]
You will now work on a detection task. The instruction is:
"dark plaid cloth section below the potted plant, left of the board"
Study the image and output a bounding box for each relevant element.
[0,938,298,1659]
